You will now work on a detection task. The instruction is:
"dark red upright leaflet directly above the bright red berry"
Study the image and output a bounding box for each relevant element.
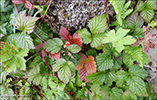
[59,26,72,41]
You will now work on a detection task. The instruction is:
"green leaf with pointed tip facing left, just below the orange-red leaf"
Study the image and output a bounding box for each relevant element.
[85,72,105,84]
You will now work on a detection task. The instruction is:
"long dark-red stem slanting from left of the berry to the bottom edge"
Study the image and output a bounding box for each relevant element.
[35,49,73,100]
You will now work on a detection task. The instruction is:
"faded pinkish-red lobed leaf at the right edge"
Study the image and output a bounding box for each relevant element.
[132,26,155,54]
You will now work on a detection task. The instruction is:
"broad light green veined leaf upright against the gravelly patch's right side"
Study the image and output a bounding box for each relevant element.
[88,14,107,34]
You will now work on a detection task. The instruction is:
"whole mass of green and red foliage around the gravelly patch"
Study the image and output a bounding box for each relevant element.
[0,0,157,100]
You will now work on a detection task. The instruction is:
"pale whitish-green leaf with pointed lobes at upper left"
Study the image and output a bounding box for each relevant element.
[15,10,39,34]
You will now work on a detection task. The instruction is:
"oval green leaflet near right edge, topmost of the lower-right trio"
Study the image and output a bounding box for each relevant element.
[129,65,148,79]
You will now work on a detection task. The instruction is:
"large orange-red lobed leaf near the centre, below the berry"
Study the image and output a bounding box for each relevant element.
[76,53,96,82]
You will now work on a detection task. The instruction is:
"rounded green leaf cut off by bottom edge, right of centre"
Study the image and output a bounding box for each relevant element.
[110,87,123,100]
